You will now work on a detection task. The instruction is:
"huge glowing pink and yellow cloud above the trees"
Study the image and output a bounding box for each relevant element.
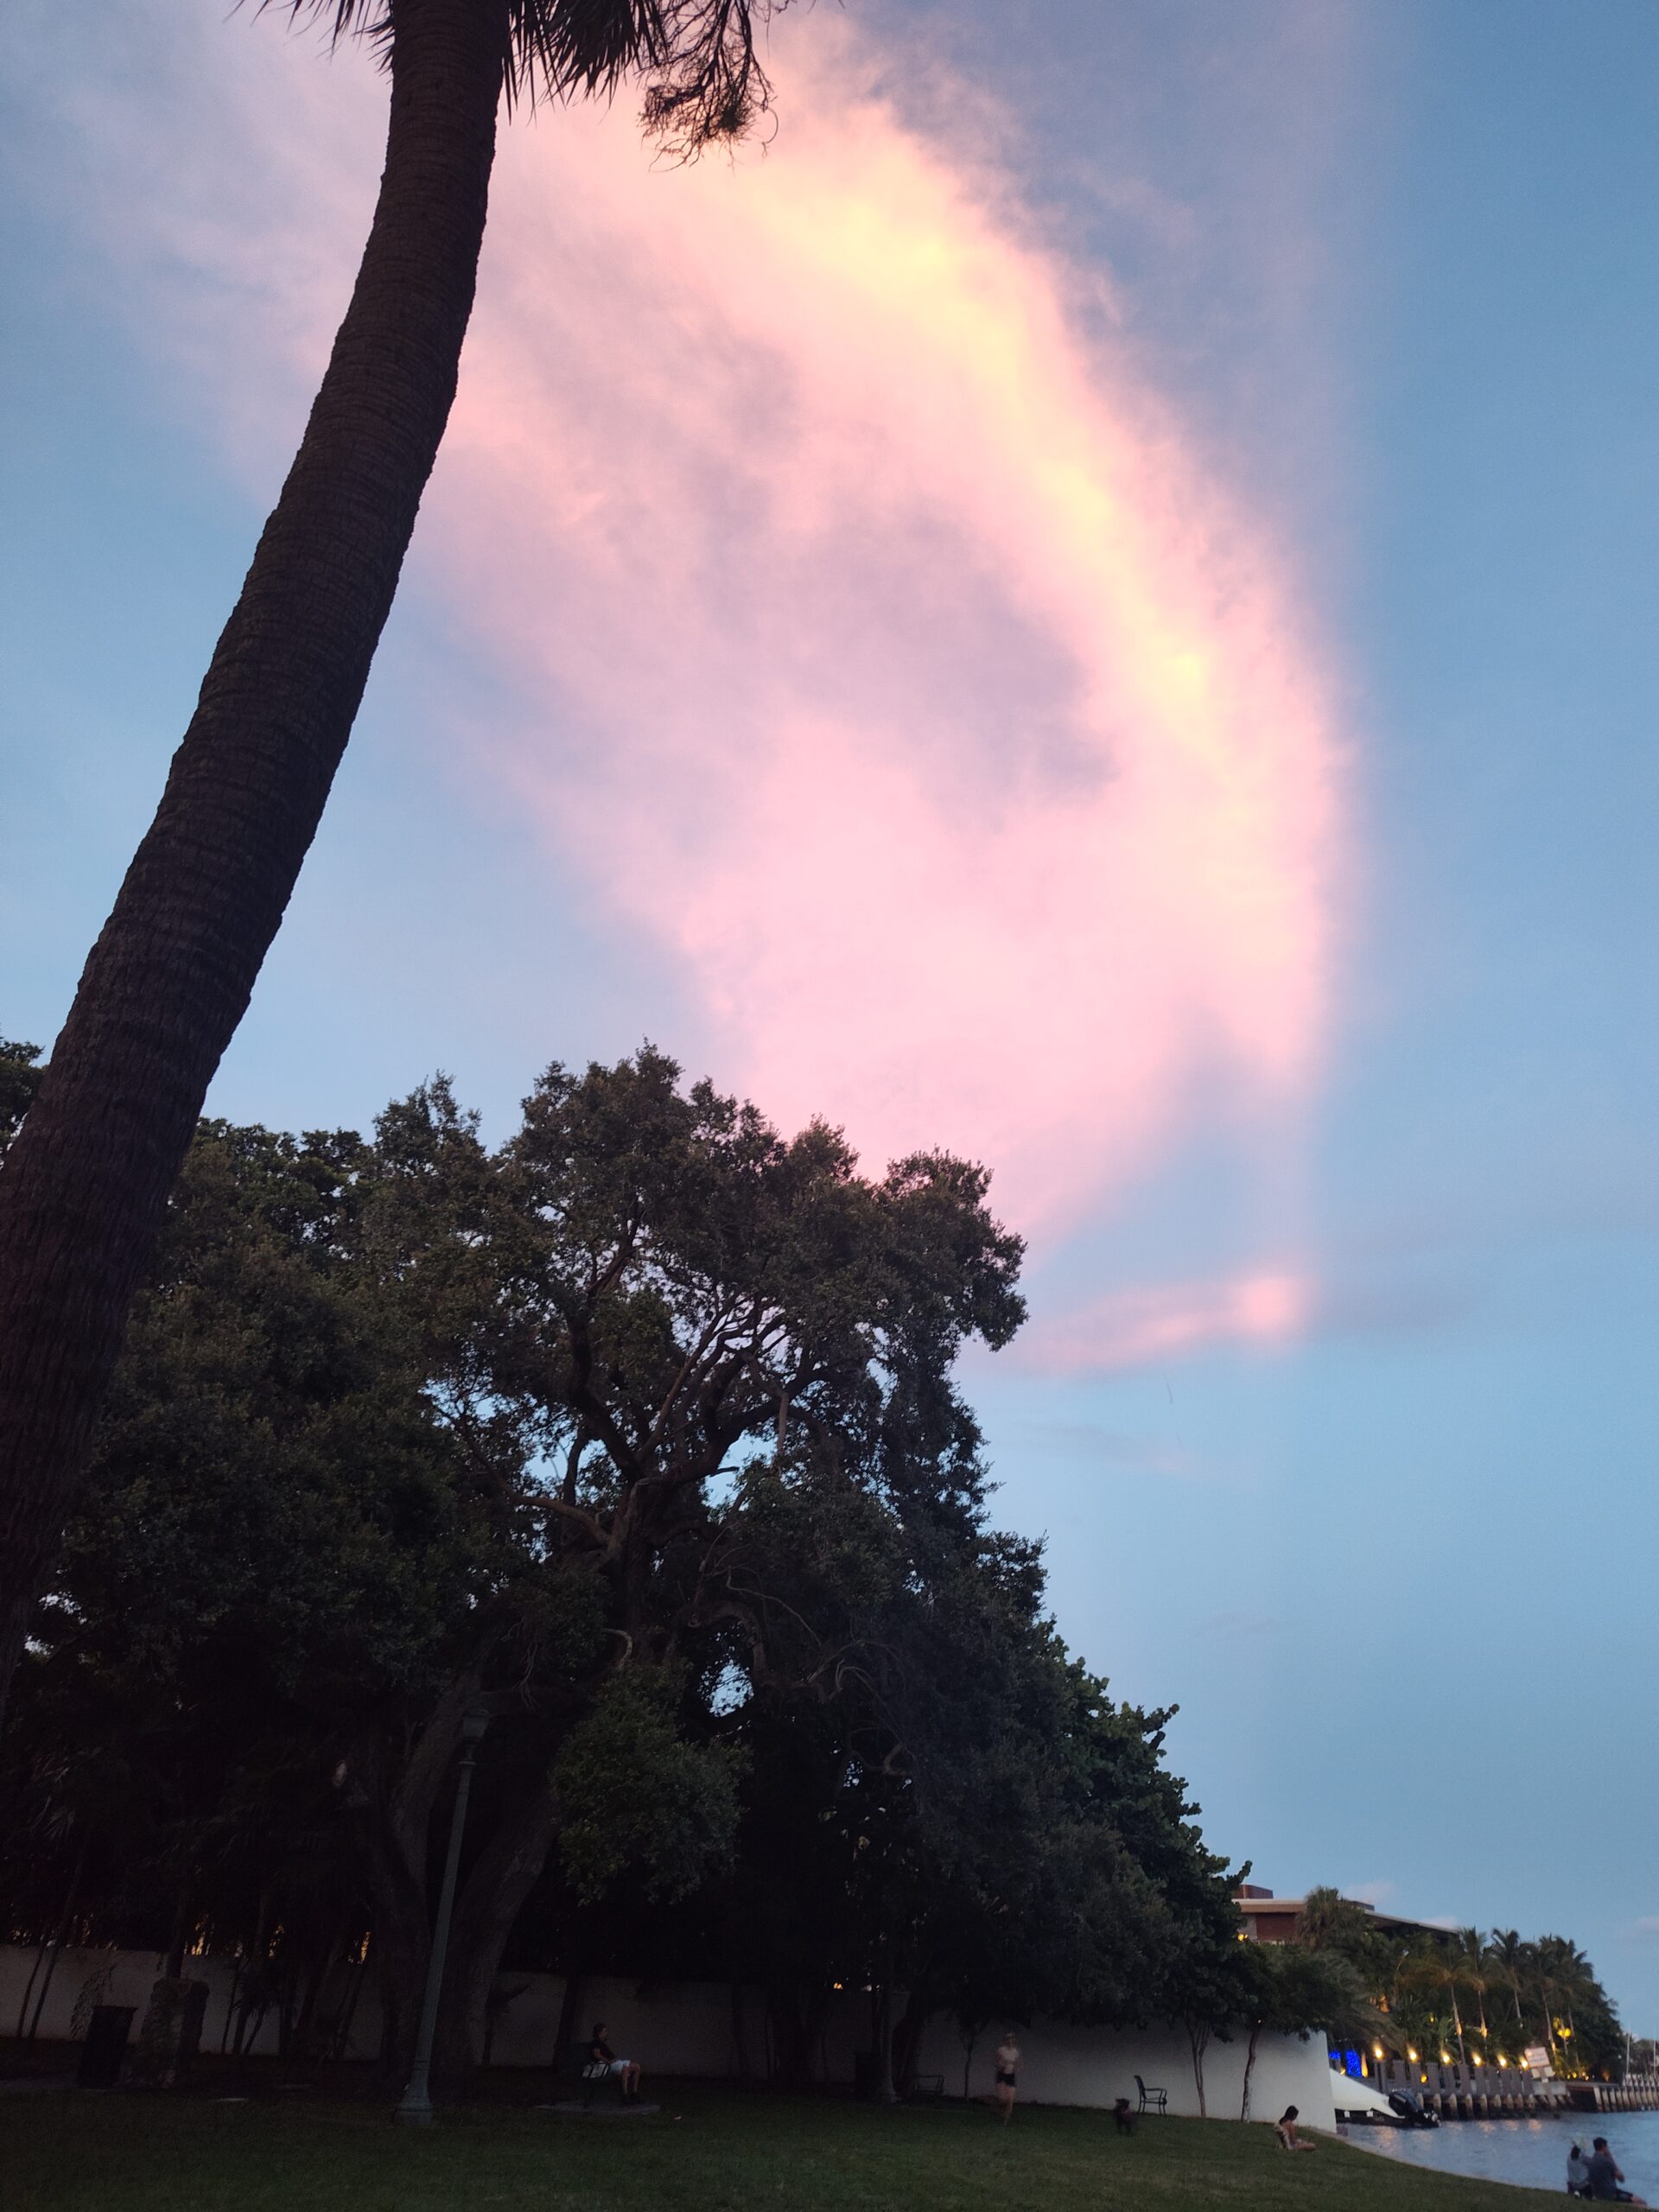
[32,9,1340,1230]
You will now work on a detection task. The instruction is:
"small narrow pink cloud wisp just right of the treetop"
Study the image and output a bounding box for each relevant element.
[1020,1272,1314,1374]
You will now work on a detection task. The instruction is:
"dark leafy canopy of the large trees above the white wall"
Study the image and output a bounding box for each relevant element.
[4,1046,1265,2073]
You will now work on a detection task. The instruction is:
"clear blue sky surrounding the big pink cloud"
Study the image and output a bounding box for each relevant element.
[0,0,1659,2031]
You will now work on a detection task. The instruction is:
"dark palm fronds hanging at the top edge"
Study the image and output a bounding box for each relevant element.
[257,0,787,159]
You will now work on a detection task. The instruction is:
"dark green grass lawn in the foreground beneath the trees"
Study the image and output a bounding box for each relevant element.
[0,2090,1544,2212]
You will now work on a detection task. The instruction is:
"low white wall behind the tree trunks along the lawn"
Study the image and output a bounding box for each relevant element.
[0,1944,1334,2128]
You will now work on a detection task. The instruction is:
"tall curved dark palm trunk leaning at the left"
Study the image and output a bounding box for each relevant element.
[0,0,506,1714]
